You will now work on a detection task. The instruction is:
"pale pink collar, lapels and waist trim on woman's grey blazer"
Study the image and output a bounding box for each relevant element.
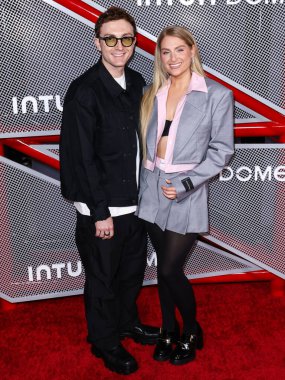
[144,72,208,173]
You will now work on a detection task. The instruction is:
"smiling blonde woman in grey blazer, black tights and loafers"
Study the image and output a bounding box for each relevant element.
[137,26,234,364]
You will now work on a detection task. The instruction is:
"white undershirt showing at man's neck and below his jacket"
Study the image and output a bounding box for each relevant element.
[74,73,140,217]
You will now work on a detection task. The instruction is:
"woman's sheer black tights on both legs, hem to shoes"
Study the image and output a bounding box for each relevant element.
[146,222,197,334]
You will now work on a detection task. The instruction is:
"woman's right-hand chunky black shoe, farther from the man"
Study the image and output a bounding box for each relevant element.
[169,323,204,365]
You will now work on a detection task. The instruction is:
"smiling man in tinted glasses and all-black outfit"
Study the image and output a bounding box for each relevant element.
[60,7,159,374]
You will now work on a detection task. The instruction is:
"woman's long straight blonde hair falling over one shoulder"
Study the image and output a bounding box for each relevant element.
[140,26,205,159]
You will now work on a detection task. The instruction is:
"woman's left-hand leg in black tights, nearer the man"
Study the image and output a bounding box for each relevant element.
[146,222,177,332]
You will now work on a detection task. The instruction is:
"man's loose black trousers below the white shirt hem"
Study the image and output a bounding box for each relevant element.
[76,212,146,349]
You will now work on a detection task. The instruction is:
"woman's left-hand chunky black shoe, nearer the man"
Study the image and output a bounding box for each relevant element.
[153,328,179,362]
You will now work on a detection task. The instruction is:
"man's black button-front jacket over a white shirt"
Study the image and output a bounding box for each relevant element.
[60,60,145,221]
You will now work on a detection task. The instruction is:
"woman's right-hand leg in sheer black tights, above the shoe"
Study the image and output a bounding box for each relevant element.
[158,230,197,334]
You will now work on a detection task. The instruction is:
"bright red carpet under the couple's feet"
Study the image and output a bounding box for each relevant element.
[0,282,285,380]
